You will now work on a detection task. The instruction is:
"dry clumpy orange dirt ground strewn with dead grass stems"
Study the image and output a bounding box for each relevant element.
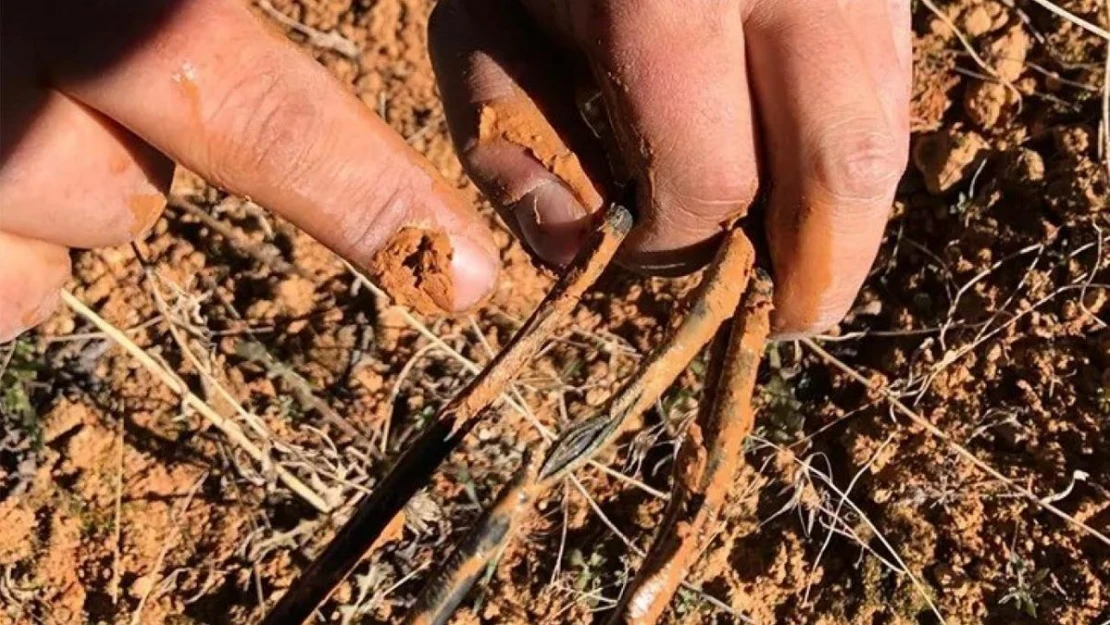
[0,0,1110,624]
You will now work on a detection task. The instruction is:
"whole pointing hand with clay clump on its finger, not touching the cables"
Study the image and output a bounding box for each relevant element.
[0,0,498,342]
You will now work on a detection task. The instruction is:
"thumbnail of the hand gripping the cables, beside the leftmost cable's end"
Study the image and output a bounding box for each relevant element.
[512,181,588,265]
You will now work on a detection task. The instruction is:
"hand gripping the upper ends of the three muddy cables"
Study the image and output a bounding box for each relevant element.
[430,0,911,335]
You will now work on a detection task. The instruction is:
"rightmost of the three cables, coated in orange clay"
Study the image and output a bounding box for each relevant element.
[609,271,771,625]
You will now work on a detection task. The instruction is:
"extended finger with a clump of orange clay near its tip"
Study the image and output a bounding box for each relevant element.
[47,0,498,312]
